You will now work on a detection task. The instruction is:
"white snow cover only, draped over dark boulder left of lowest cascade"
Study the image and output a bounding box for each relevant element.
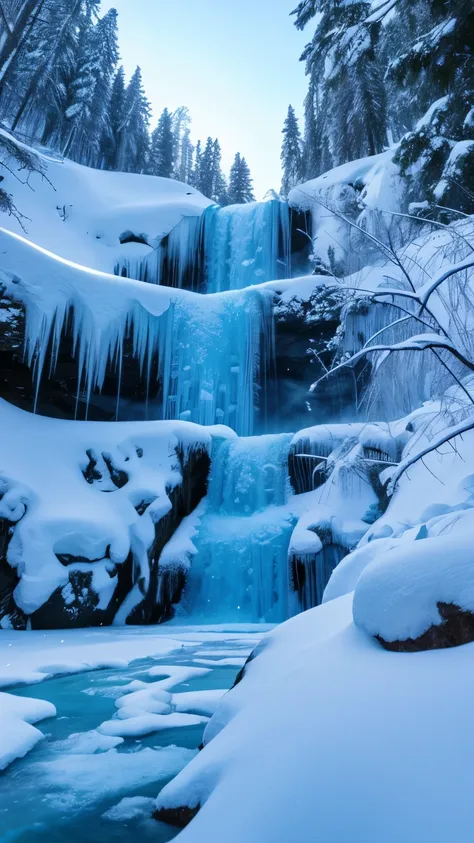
[0,400,212,620]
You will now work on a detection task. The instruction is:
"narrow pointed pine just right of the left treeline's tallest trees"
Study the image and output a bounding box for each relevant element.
[114,67,150,173]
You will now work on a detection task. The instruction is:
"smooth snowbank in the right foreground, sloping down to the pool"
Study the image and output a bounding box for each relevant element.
[157,595,474,843]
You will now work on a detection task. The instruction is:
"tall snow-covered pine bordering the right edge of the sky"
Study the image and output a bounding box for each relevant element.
[293,0,387,177]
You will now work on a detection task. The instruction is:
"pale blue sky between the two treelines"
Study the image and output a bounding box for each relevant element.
[98,0,312,198]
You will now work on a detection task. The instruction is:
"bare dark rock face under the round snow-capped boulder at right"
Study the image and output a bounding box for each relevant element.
[376,603,474,653]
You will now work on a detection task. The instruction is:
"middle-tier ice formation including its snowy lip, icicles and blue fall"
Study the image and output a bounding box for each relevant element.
[0,231,274,435]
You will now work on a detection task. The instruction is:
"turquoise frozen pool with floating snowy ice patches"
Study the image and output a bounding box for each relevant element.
[0,634,258,843]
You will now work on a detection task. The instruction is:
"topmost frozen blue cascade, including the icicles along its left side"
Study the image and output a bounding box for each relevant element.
[115,199,291,293]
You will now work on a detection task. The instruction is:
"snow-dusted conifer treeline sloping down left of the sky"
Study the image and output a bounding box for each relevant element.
[0,0,254,205]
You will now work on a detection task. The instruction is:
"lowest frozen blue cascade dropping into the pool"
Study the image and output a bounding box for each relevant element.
[182,434,295,623]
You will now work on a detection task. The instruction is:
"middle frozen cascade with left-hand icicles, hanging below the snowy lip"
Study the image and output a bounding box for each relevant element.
[25,291,274,436]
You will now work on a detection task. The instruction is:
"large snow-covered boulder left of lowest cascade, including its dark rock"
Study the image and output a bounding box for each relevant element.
[0,401,212,628]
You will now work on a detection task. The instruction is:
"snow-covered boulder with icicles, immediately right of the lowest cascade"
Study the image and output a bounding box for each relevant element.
[288,423,409,610]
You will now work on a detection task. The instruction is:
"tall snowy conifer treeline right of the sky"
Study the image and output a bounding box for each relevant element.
[282,0,474,212]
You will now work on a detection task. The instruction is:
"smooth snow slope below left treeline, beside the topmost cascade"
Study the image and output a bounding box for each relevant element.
[0,130,212,273]
